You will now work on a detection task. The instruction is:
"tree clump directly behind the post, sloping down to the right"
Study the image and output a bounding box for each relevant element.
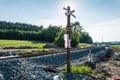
[54,22,93,47]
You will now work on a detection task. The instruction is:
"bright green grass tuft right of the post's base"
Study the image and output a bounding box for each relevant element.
[71,65,92,74]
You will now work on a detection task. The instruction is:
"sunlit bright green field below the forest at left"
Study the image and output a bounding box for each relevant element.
[0,40,46,48]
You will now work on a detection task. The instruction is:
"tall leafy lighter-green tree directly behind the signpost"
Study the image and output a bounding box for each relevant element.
[55,22,82,47]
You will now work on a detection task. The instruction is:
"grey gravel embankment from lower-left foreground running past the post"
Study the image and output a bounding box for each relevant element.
[0,47,104,80]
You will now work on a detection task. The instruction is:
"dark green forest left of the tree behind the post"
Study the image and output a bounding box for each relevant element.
[0,21,60,42]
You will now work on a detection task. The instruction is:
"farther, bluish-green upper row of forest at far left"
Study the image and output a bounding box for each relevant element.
[0,21,43,31]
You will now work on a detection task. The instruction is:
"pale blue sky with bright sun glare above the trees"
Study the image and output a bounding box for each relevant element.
[0,0,120,42]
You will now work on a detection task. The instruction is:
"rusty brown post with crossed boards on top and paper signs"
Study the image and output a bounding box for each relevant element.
[63,6,76,73]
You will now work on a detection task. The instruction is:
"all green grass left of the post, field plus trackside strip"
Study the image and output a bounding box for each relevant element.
[0,39,62,55]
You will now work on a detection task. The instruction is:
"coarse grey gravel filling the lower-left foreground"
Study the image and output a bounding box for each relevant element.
[0,59,55,80]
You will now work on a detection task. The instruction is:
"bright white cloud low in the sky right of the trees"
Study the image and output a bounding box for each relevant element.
[86,19,120,42]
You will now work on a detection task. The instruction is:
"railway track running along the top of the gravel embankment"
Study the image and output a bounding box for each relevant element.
[0,47,107,60]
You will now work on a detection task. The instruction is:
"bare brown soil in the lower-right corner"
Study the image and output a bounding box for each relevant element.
[95,55,120,80]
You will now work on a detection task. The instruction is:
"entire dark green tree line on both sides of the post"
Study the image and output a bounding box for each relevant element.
[0,21,93,46]
